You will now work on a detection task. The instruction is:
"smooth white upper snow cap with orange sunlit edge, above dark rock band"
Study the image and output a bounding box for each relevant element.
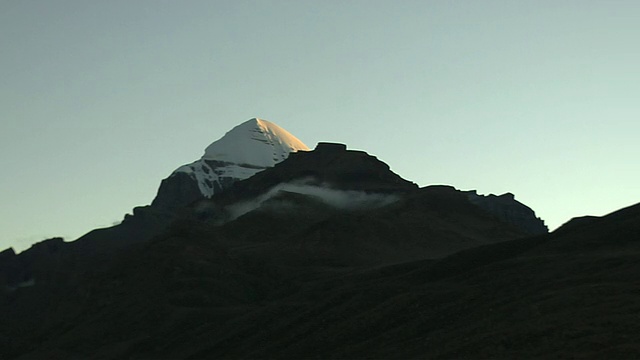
[202,118,309,167]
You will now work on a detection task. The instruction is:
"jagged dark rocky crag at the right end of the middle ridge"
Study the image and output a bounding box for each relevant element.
[466,190,549,235]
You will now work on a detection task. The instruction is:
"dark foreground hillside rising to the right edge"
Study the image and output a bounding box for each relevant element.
[196,201,640,358]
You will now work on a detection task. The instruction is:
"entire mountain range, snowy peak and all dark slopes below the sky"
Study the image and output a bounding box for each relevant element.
[0,118,640,359]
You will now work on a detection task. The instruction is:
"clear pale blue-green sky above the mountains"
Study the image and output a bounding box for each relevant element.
[0,0,640,251]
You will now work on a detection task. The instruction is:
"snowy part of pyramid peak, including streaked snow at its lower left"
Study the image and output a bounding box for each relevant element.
[174,118,309,197]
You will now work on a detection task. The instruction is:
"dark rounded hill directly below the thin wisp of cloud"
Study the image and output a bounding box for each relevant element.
[215,186,522,266]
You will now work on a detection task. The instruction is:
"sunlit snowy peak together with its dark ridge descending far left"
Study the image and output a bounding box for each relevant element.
[0,118,309,264]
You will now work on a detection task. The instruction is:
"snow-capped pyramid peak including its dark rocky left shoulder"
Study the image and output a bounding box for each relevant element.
[151,118,309,210]
